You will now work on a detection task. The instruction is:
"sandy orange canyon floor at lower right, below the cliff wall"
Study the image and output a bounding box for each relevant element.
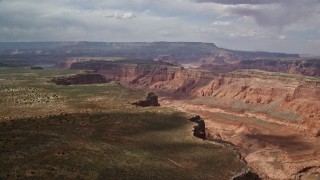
[160,98,320,179]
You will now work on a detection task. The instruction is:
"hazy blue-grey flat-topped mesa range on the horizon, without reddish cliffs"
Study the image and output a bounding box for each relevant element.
[0,41,300,64]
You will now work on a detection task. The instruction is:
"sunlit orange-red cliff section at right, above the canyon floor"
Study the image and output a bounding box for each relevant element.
[195,73,320,136]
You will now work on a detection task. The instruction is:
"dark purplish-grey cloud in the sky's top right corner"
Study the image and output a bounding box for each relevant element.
[196,0,320,29]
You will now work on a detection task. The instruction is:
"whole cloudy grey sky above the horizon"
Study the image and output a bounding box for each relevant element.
[0,0,320,55]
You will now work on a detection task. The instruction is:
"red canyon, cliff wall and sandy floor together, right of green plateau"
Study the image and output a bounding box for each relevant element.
[63,60,320,179]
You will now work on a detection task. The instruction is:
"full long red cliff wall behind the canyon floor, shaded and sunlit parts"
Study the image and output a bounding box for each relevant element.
[71,63,320,136]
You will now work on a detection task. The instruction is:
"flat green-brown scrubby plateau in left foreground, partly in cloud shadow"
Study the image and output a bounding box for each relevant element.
[0,68,244,179]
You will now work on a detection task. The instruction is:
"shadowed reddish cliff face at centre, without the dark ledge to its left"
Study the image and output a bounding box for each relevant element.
[98,65,214,93]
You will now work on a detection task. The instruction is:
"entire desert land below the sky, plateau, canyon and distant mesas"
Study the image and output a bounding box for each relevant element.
[0,42,320,179]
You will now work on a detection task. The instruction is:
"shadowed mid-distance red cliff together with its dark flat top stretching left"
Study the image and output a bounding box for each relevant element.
[70,61,213,93]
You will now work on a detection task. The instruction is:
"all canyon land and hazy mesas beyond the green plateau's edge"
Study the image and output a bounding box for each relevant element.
[0,42,320,179]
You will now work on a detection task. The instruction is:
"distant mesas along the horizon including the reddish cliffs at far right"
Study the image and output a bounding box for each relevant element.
[0,41,320,76]
